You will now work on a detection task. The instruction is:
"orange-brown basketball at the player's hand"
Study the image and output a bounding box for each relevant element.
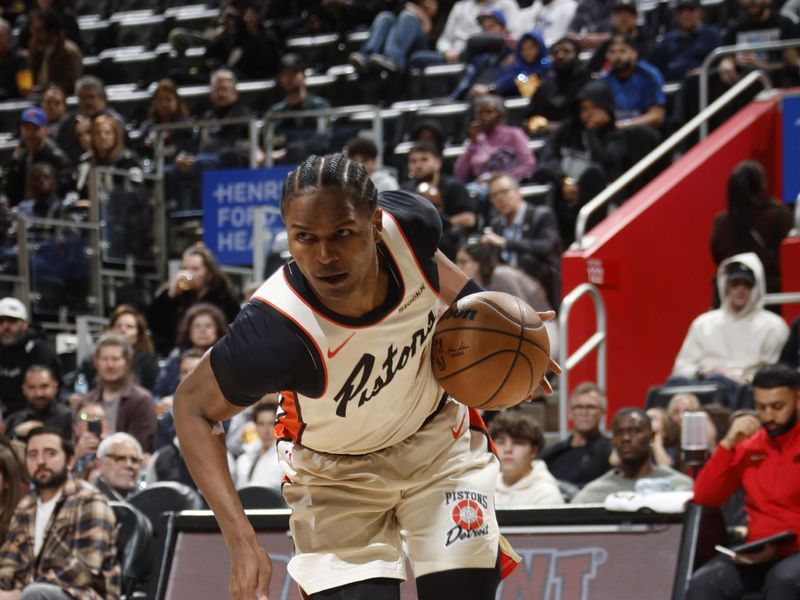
[431,292,550,410]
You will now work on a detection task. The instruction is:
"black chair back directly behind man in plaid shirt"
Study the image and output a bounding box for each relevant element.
[109,502,153,597]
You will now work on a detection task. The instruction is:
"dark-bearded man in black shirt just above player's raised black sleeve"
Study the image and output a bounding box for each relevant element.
[403,142,478,260]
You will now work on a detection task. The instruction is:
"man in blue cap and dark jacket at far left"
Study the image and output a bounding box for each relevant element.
[5,106,73,206]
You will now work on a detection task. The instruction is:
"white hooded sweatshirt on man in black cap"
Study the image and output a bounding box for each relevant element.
[672,252,789,380]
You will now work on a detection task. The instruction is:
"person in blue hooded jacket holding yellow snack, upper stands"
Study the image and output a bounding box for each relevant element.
[470,31,549,98]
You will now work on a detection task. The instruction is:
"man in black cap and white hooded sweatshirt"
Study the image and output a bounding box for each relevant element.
[667,252,789,408]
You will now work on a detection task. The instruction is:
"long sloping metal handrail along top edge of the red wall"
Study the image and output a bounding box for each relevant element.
[572,71,769,249]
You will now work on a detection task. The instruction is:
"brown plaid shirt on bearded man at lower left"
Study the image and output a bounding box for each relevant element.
[0,477,121,600]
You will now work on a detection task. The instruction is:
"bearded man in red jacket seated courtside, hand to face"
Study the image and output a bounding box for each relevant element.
[686,365,800,600]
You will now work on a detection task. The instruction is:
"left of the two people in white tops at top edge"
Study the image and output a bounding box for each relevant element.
[411,0,519,67]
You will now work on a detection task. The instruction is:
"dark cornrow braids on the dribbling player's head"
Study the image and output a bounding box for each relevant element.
[281,152,378,215]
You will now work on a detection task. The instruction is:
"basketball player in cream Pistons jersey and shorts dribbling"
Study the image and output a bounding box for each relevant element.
[174,154,558,600]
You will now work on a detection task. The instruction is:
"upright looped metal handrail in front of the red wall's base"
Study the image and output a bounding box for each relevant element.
[558,283,607,439]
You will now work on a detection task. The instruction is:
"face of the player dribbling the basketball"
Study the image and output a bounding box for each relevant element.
[284,188,383,314]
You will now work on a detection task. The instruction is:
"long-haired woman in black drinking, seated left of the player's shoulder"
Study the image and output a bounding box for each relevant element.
[146,242,239,356]
